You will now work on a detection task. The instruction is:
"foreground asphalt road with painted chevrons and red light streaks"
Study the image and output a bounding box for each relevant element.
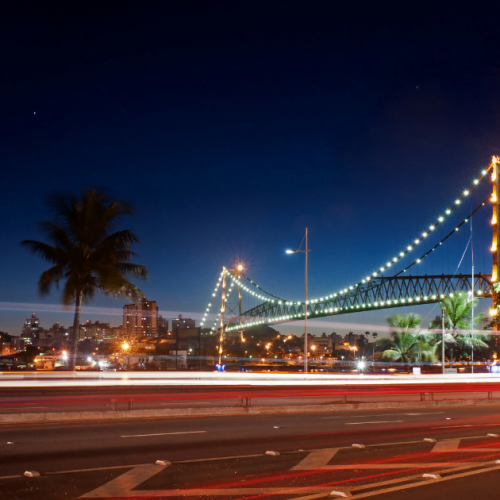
[0,405,500,500]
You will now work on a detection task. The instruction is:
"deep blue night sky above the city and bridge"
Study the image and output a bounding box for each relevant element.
[0,0,500,335]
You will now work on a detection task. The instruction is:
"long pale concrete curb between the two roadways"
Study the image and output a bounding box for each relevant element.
[0,399,500,424]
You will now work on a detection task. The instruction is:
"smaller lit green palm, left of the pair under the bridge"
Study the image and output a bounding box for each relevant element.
[377,313,430,363]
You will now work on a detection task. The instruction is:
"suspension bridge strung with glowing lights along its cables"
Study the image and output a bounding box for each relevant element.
[201,157,500,343]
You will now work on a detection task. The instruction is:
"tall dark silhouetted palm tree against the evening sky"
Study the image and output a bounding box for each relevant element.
[21,189,148,369]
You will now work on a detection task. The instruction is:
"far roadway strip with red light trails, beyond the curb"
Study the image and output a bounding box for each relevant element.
[0,382,500,413]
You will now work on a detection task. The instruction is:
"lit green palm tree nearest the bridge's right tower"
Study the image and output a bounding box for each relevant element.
[429,293,488,356]
